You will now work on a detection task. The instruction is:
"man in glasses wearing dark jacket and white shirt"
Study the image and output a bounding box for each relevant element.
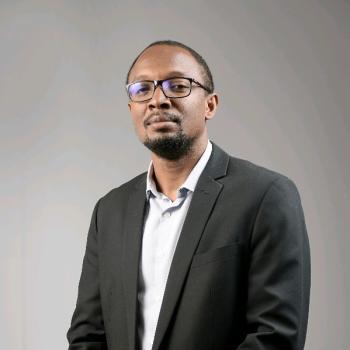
[67,41,310,350]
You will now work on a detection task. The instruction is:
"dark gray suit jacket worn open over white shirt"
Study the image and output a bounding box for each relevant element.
[67,144,310,350]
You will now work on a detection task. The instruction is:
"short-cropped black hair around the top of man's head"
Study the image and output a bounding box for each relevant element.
[125,40,214,93]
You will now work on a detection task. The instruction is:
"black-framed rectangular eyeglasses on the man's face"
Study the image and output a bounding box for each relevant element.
[126,77,211,102]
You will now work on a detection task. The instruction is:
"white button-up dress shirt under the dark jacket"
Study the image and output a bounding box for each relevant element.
[138,141,212,350]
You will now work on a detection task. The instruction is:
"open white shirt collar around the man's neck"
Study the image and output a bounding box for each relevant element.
[146,140,213,199]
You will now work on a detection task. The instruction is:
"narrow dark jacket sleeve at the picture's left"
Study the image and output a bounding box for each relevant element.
[67,201,107,350]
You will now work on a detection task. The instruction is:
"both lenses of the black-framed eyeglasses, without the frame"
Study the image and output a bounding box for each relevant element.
[128,78,191,102]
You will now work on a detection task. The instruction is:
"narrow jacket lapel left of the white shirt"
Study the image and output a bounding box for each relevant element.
[123,175,146,350]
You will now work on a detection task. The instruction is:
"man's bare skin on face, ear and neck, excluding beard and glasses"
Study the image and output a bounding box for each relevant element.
[128,45,218,200]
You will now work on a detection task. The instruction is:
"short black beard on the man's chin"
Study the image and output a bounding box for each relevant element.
[143,131,195,160]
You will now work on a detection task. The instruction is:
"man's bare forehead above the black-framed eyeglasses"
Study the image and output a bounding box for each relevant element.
[130,45,200,81]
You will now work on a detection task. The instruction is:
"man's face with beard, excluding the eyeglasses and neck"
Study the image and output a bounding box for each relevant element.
[128,45,216,159]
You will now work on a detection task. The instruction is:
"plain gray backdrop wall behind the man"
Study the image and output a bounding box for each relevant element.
[0,0,350,350]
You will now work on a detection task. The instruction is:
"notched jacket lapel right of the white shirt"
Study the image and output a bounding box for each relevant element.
[152,143,229,350]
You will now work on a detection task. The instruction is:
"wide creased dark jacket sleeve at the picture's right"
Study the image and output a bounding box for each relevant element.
[237,177,311,350]
